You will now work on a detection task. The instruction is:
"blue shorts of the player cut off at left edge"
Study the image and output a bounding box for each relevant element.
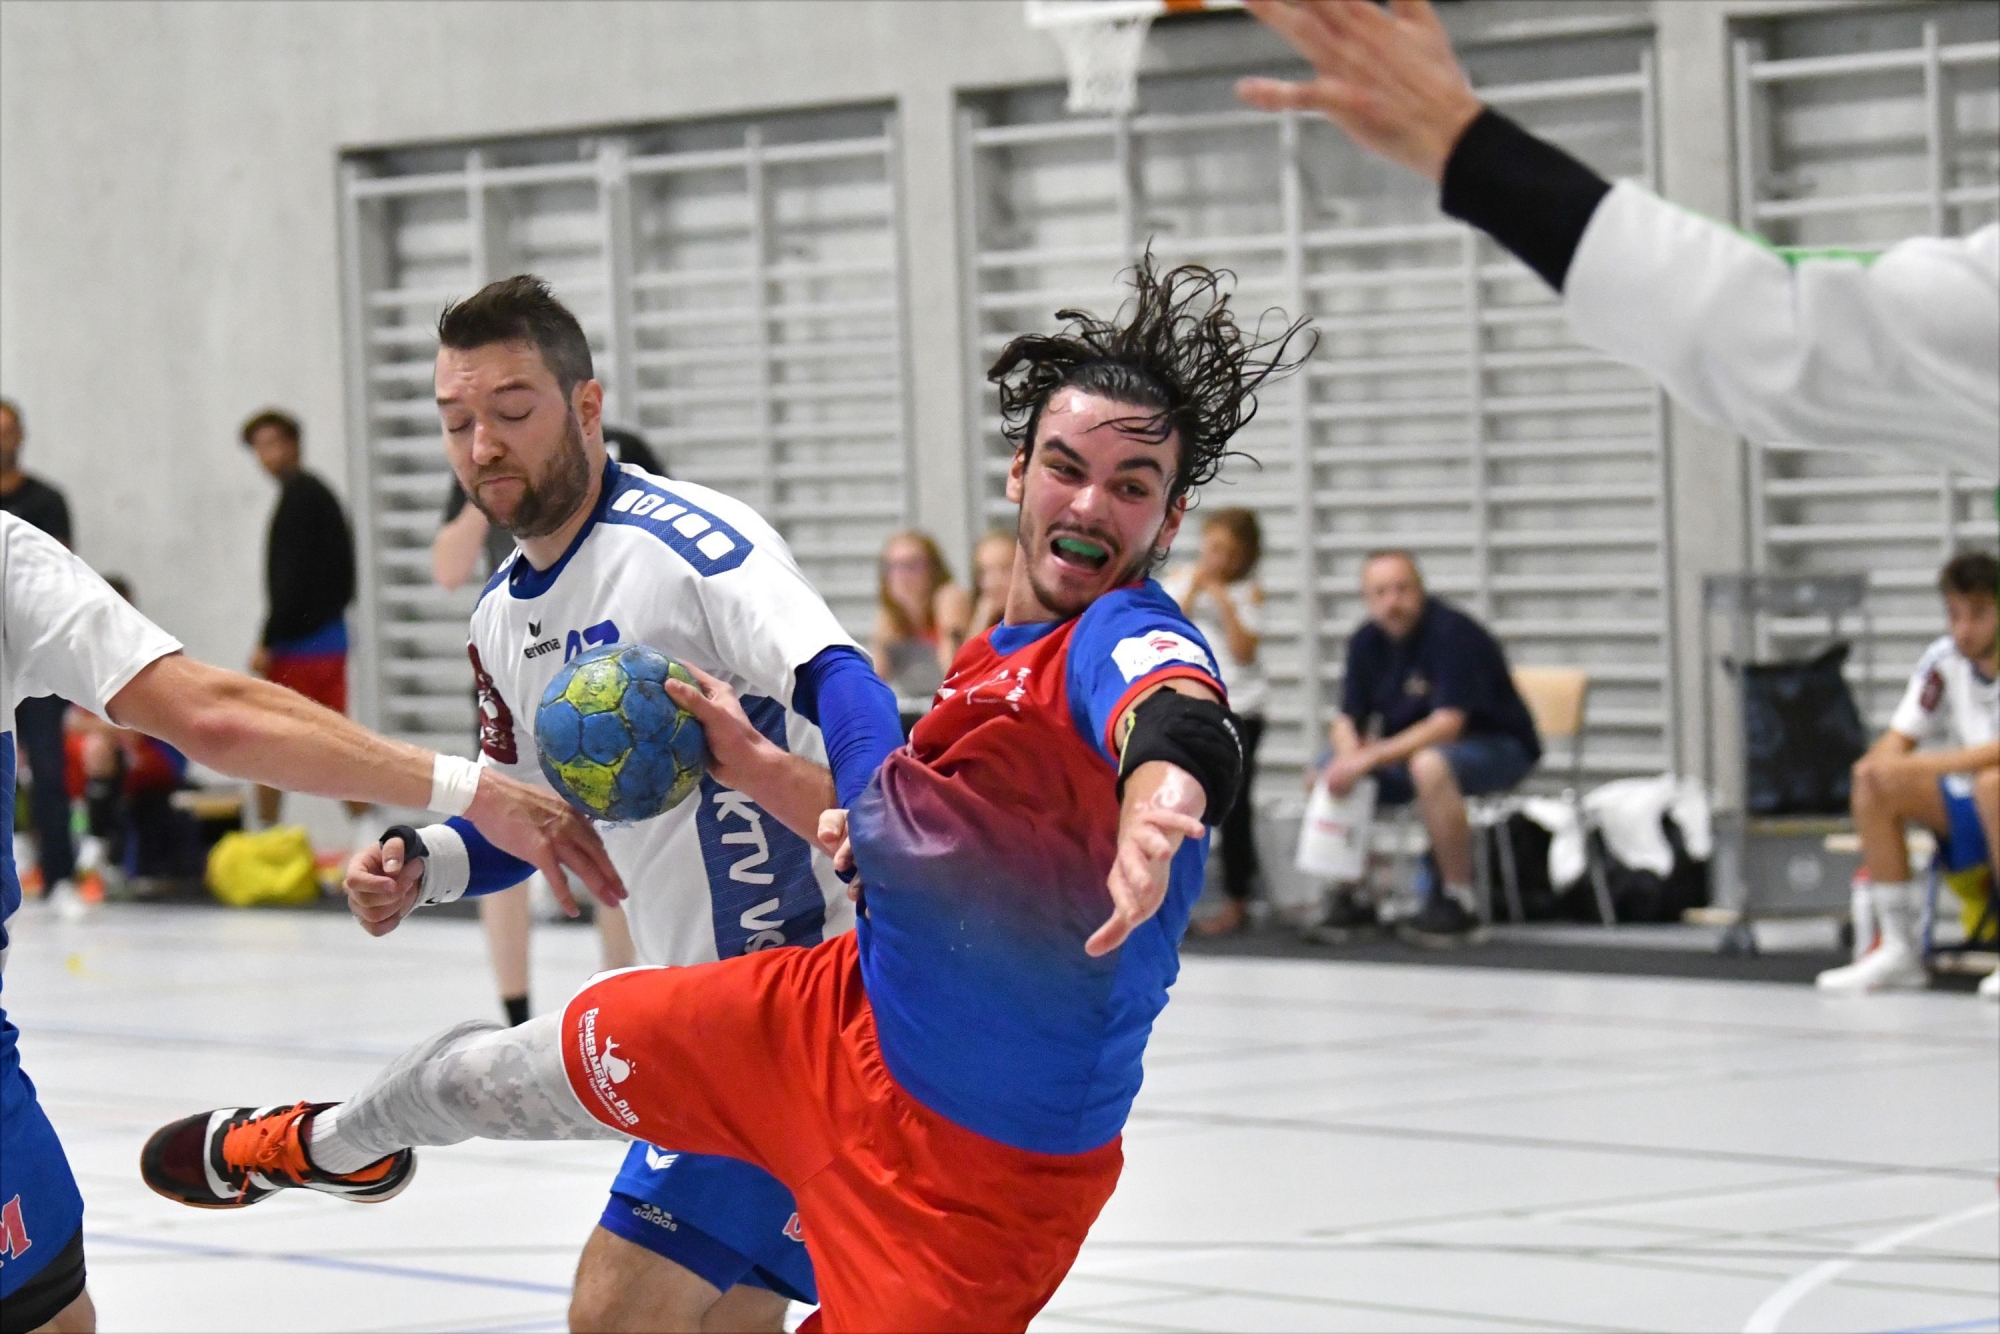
[0,1010,84,1300]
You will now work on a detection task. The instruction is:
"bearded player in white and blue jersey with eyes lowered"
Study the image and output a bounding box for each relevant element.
[306,278,902,1330]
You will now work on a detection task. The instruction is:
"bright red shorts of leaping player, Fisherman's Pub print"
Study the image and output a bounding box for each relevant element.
[562,932,1124,1330]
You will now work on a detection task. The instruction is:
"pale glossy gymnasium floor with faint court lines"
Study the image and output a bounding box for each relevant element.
[6,904,2000,1334]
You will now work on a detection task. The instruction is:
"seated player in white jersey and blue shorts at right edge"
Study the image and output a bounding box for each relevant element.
[1818,552,2000,996]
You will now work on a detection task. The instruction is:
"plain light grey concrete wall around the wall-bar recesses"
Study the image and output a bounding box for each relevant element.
[0,0,1896,792]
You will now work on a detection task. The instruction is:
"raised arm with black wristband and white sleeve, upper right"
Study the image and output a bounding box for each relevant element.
[1236,0,2000,480]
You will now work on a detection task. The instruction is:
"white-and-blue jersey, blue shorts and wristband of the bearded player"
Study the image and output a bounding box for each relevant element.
[422,464,860,1300]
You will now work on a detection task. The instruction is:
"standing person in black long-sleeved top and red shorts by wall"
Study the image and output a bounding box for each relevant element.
[242,408,370,846]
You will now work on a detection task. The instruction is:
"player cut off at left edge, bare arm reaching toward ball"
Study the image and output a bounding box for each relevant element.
[0,514,620,1334]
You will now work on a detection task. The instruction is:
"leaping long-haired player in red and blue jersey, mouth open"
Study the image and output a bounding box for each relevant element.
[142,258,1310,1330]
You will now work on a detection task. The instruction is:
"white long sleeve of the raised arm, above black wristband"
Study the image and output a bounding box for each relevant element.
[1562,182,2000,478]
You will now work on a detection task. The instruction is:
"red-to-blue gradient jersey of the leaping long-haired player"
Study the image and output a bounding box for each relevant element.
[850,580,1222,1154]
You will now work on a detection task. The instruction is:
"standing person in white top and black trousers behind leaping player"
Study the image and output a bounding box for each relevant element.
[1164,510,1268,936]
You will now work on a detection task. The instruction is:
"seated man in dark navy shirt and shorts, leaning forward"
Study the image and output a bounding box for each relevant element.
[1324,550,1542,944]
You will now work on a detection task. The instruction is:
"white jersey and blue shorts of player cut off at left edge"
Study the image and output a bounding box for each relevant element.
[0,512,180,1300]
